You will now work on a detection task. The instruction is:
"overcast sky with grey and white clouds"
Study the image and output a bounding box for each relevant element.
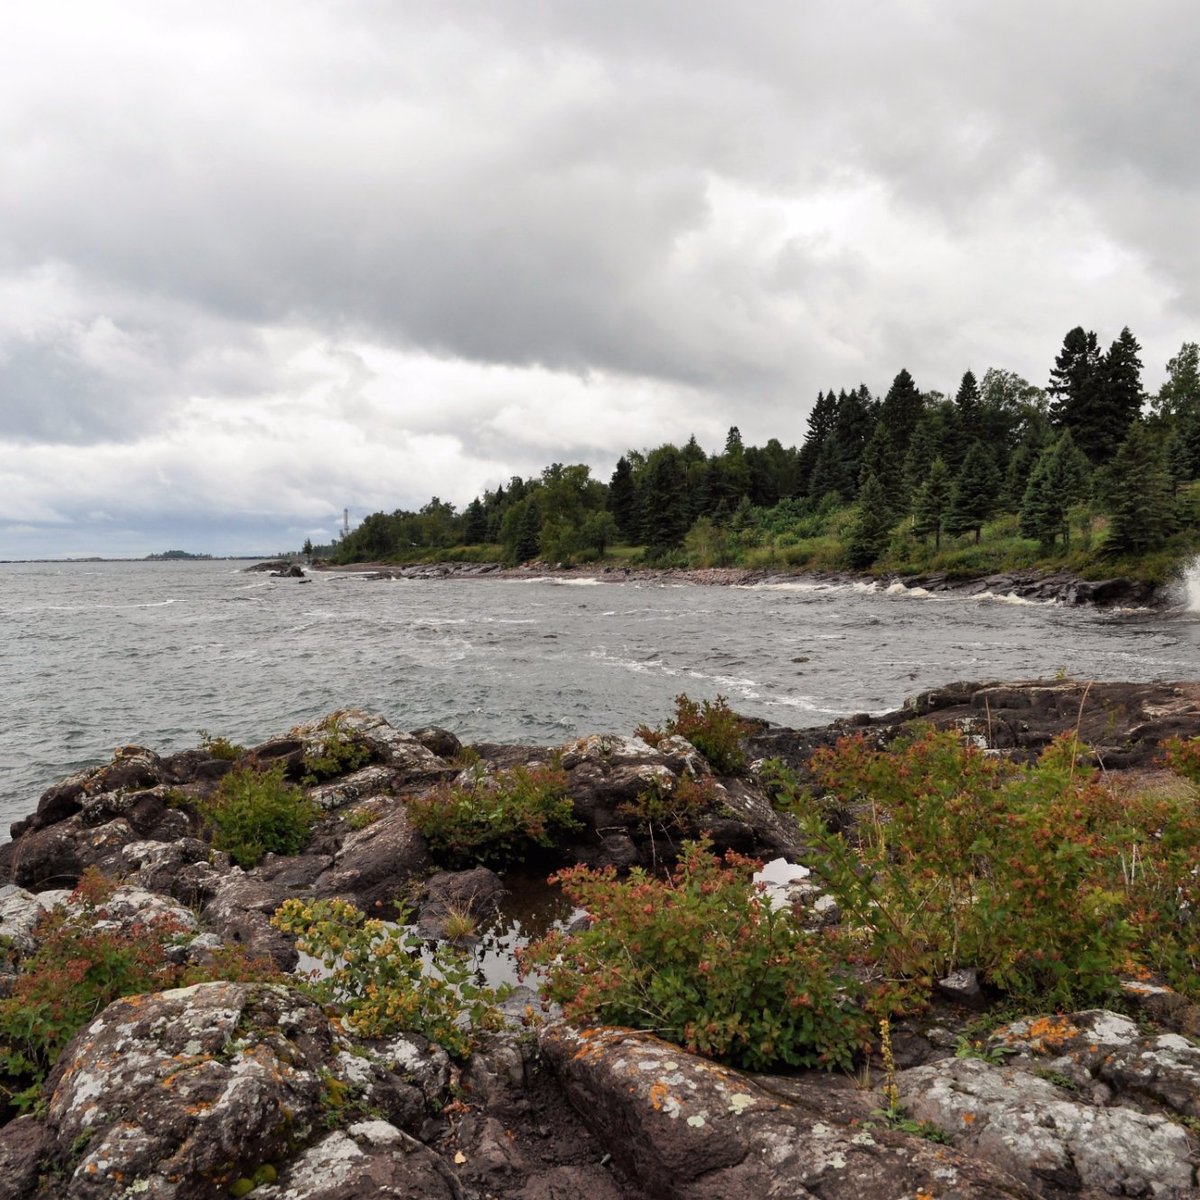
[0,0,1200,558]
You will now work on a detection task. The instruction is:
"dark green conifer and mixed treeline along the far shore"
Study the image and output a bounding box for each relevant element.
[334,326,1200,568]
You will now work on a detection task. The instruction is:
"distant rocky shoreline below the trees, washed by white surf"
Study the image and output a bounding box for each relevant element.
[302,563,1177,608]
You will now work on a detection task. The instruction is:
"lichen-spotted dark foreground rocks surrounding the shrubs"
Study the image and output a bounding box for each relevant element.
[0,680,1200,1200]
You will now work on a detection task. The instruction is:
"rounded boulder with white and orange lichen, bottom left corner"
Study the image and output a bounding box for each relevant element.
[37,983,348,1200]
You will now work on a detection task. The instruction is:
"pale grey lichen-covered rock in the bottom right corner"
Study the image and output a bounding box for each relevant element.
[899,1058,1195,1200]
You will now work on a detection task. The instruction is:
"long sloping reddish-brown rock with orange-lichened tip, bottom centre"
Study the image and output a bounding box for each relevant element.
[541,1025,1034,1200]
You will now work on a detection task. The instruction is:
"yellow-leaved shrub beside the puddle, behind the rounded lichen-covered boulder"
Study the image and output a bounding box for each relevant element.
[271,900,511,1058]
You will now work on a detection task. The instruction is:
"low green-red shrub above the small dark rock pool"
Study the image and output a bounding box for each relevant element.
[408,767,576,866]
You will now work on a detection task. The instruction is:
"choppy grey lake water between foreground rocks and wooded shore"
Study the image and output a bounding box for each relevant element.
[0,563,1200,829]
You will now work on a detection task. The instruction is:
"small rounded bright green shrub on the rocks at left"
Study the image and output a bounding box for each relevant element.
[202,763,320,869]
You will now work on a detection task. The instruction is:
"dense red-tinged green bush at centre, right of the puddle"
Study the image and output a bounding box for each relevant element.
[518,842,871,1068]
